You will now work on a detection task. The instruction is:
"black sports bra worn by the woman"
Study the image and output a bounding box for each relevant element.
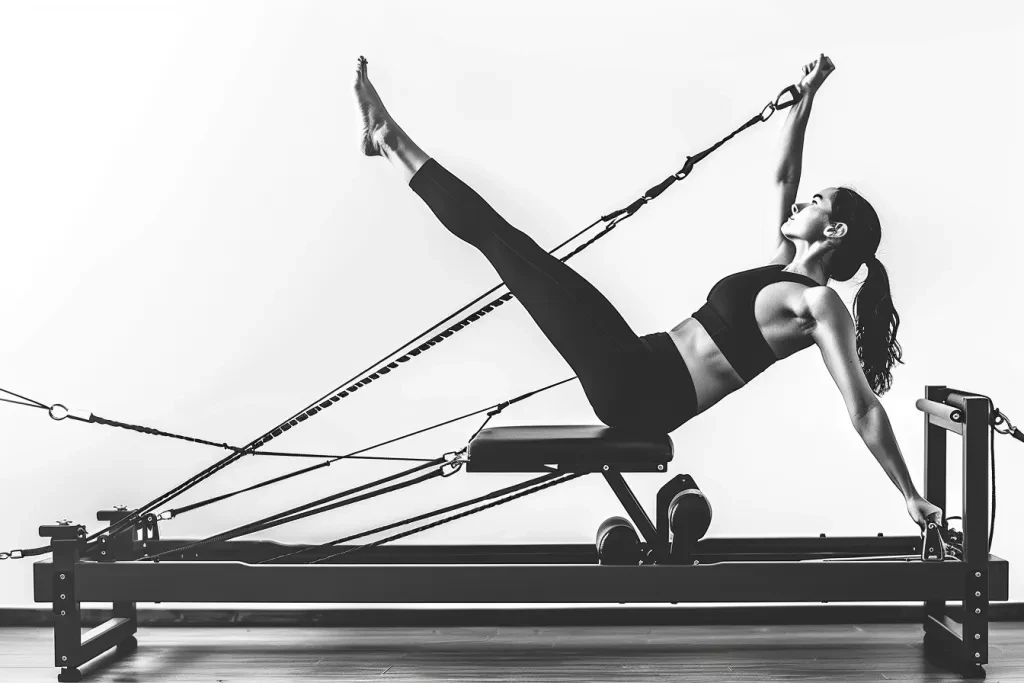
[693,264,820,382]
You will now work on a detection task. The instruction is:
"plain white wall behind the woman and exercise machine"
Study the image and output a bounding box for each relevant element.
[0,0,1024,605]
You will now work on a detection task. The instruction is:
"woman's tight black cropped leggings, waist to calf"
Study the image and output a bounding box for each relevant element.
[409,159,696,434]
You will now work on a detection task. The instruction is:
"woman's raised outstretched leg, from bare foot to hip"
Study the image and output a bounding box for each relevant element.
[355,57,667,426]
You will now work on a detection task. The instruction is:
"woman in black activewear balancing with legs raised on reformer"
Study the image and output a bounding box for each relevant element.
[354,54,941,526]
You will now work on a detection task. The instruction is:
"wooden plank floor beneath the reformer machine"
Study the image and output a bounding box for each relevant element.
[0,623,1024,683]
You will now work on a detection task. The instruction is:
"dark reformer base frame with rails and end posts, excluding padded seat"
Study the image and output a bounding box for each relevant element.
[34,386,1009,681]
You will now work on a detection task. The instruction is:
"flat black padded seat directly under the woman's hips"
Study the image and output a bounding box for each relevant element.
[466,425,672,472]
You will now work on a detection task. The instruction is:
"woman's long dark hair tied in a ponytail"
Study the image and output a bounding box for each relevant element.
[828,186,903,396]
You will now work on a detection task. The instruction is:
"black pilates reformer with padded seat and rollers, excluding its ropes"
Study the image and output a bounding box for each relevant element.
[19,386,1019,681]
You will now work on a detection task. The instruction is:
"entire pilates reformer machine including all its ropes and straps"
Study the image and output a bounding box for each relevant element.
[0,80,1024,681]
